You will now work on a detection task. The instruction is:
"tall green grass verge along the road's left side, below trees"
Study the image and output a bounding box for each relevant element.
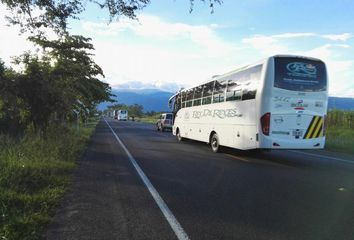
[0,121,97,240]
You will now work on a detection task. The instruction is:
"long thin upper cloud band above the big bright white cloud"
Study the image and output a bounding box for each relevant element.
[83,15,234,56]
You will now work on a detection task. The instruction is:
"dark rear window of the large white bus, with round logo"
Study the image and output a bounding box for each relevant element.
[274,57,327,92]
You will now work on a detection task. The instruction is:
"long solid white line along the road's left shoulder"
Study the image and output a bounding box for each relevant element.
[103,118,189,240]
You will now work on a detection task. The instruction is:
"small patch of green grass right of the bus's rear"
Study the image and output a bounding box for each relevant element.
[326,127,354,154]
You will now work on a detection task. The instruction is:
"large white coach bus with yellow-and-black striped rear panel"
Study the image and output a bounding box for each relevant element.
[169,55,328,152]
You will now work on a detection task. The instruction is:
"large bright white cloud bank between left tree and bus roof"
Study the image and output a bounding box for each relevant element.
[77,16,245,91]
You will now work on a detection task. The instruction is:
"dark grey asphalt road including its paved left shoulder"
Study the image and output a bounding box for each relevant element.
[43,118,354,240]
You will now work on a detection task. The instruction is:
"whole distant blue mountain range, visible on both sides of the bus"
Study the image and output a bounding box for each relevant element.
[98,89,354,112]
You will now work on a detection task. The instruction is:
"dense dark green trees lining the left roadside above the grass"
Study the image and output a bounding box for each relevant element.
[0,35,112,134]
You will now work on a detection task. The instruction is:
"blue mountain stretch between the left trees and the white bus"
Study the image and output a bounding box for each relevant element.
[98,89,173,112]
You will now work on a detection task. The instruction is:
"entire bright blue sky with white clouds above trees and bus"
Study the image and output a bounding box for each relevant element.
[0,0,354,97]
